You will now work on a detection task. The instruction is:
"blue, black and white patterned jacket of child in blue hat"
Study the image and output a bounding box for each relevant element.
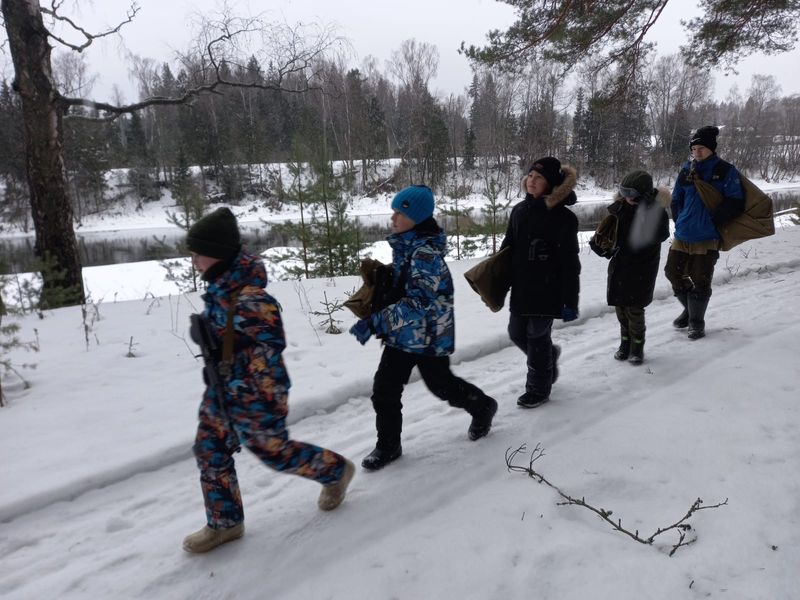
[371,225,455,356]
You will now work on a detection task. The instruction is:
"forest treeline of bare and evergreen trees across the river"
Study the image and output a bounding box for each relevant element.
[0,40,800,229]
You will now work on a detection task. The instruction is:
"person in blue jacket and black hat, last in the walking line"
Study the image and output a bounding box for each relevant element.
[664,125,744,340]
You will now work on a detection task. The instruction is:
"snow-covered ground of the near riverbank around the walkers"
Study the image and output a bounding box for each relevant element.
[0,206,800,600]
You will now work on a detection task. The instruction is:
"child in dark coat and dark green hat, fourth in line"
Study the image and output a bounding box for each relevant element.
[589,171,670,365]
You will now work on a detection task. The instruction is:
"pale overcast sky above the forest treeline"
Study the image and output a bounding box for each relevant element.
[4,0,800,100]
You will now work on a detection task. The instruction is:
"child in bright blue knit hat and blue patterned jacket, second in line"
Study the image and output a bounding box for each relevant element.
[350,185,497,471]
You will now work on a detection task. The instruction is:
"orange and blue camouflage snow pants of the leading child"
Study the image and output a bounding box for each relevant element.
[193,390,345,529]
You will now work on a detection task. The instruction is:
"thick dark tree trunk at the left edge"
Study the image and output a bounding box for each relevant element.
[0,0,84,308]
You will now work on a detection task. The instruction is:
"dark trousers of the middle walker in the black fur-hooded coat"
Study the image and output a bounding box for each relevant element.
[508,313,553,397]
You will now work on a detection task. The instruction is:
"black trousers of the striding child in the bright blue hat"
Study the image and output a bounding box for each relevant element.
[372,346,489,450]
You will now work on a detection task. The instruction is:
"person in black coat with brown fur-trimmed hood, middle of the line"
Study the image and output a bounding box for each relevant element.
[501,156,581,408]
